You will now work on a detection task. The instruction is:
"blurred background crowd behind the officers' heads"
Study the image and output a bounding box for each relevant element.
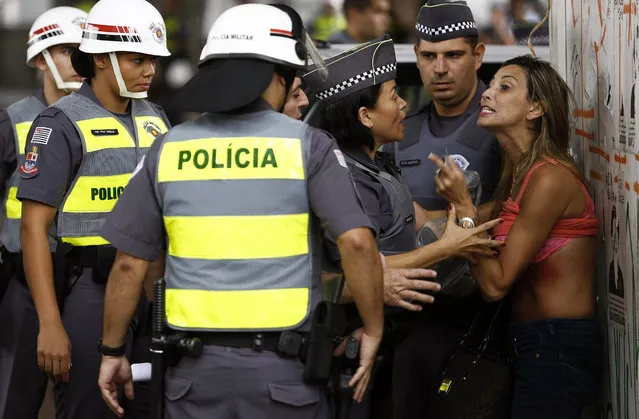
[0,0,548,123]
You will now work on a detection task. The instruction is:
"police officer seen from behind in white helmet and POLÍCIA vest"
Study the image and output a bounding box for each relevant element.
[98,4,383,419]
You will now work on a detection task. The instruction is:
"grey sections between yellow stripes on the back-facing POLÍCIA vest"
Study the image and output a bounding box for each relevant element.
[156,111,319,331]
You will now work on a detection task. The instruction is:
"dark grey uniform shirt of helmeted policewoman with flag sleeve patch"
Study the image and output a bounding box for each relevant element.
[17,82,170,212]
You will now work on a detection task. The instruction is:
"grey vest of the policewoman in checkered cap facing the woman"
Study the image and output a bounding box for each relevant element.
[344,153,417,255]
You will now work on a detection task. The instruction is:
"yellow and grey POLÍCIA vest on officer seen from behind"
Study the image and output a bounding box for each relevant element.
[156,112,319,331]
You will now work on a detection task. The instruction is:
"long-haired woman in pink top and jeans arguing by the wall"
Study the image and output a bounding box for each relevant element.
[430,56,603,419]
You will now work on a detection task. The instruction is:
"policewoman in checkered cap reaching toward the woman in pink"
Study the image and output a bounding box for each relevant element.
[304,35,502,418]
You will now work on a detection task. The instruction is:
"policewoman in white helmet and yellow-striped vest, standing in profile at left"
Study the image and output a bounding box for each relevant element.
[17,0,169,419]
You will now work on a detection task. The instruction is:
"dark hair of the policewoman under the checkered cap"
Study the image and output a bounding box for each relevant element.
[319,84,382,150]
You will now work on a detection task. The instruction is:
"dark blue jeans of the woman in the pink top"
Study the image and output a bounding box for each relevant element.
[510,319,603,419]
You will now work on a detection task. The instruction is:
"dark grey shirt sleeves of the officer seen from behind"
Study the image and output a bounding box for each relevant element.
[100,100,373,261]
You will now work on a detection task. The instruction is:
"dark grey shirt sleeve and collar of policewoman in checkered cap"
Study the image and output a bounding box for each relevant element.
[325,147,393,263]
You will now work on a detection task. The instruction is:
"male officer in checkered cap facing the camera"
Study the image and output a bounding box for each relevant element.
[386,0,501,418]
